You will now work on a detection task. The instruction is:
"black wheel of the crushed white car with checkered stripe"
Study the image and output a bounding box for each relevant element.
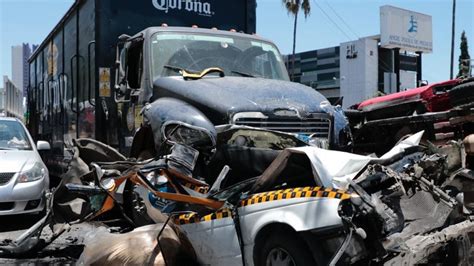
[255,232,317,266]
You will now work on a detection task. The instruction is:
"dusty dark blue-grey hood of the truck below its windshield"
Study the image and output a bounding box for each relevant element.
[153,77,327,116]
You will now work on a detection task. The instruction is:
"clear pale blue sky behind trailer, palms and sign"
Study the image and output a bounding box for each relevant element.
[0,0,474,82]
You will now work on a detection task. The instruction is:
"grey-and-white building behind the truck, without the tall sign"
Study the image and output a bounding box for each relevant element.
[284,35,421,108]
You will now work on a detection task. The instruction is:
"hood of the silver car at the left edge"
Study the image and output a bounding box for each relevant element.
[0,150,41,173]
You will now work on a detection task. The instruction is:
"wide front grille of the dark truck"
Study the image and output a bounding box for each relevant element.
[234,114,331,139]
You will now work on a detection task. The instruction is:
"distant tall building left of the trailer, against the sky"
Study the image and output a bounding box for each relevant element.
[12,43,38,97]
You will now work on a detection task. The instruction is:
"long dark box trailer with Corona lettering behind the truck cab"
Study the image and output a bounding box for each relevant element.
[27,0,256,175]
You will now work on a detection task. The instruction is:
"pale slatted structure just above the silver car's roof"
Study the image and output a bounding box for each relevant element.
[0,76,24,120]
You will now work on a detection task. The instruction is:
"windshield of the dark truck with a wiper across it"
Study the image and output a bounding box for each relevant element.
[151,32,289,80]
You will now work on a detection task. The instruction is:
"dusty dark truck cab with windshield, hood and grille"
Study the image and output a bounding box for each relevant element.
[115,26,351,158]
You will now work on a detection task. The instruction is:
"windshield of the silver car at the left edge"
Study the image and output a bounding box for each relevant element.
[0,120,31,150]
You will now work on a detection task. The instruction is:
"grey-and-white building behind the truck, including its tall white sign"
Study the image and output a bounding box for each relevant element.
[285,5,433,108]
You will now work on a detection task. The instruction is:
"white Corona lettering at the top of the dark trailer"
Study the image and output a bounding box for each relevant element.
[152,0,213,16]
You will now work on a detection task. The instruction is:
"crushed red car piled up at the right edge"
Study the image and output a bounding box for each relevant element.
[345,78,474,153]
